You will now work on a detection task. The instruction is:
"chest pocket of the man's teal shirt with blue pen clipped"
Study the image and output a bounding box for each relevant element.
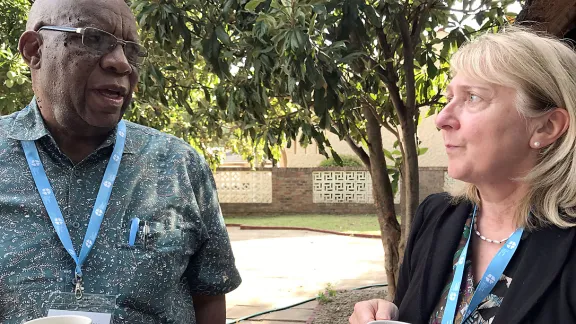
[115,220,207,308]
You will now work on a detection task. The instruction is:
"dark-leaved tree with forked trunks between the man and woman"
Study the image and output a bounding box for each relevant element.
[133,0,512,295]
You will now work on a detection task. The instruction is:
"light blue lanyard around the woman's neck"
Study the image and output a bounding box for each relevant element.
[442,206,524,324]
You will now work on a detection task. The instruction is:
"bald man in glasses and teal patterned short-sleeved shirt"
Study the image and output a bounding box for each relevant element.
[0,0,241,324]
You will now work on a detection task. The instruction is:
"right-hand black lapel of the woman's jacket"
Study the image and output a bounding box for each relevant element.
[494,227,575,324]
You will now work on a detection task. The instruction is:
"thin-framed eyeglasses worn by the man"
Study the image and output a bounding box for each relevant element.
[38,26,148,66]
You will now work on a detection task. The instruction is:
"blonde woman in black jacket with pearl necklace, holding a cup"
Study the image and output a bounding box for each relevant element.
[350,28,576,324]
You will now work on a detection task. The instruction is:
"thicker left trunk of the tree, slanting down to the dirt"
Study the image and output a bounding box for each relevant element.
[363,108,401,298]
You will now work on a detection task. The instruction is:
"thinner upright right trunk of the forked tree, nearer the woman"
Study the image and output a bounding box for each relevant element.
[399,116,420,260]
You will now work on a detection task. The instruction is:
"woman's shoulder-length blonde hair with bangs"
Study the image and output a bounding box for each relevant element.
[451,27,576,228]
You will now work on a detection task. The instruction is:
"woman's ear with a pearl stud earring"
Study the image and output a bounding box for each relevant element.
[530,108,570,149]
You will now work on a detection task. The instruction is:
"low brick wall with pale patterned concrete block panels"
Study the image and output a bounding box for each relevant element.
[214,167,452,216]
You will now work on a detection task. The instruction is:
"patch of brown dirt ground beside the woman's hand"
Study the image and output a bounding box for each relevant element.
[310,287,387,324]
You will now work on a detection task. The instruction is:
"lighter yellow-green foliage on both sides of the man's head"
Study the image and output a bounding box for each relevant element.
[0,0,264,167]
